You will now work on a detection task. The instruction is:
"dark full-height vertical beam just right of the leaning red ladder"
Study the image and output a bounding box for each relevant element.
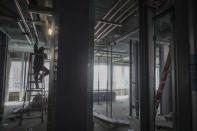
[172,0,192,131]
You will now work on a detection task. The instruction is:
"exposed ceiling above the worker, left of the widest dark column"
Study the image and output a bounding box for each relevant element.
[0,0,51,52]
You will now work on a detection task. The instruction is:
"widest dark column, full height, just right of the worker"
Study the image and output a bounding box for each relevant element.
[54,0,94,131]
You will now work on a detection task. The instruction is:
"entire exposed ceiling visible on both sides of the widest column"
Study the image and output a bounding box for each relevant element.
[0,0,173,63]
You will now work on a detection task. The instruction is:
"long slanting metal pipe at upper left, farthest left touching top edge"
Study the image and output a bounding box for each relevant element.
[14,0,33,44]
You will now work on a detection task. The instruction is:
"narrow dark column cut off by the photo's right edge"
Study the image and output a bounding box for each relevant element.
[188,0,197,131]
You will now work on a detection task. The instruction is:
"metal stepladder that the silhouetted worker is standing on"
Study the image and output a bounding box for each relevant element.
[19,53,46,126]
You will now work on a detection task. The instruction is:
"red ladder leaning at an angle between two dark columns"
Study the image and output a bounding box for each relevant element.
[155,50,171,116]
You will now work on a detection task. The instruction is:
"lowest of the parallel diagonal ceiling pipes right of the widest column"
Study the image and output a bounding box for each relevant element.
[96,2,136,39]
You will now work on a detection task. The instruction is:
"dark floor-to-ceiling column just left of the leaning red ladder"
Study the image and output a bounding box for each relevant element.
[139,0,155,131]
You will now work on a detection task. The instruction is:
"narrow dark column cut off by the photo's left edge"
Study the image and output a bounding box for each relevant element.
[0,32,8,121]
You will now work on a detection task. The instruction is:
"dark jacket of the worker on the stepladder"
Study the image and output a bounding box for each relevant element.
[34,44,47,72]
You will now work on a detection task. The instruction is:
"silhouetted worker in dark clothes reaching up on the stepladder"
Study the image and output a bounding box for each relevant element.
[33,42,49,89]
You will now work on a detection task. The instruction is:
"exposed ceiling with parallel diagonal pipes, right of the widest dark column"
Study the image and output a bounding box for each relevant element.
[94,0,173,64]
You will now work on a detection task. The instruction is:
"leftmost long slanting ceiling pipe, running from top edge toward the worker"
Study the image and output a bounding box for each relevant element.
[14,0,33,44]
